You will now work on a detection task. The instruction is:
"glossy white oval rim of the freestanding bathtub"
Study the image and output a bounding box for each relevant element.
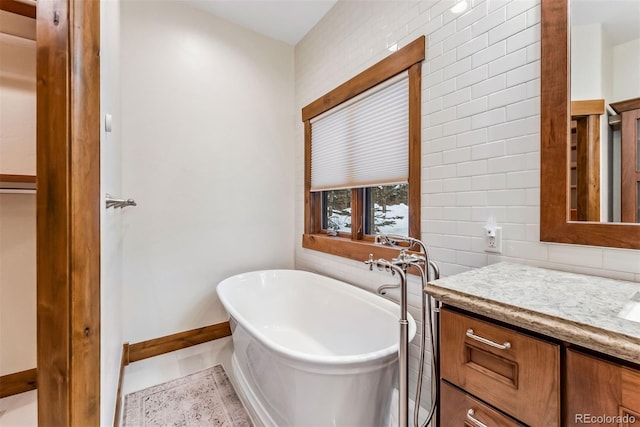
[216,269,417,367]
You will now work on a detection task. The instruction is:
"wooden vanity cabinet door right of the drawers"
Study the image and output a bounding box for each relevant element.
[564,349,640,427]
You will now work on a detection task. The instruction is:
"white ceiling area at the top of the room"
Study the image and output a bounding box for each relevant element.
[183,0,336,45]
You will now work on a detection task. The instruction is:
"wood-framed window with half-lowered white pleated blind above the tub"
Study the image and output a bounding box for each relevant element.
[302,36,425,260]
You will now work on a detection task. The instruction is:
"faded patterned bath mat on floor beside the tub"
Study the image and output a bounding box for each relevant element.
[123,365,252,427]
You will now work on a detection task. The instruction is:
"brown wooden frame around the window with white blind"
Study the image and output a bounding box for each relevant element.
[302,36,425,261]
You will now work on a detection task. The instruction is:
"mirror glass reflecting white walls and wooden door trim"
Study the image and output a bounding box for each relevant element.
[569,0,640,223]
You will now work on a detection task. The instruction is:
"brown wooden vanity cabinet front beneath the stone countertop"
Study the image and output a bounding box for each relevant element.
[440,307,640,427]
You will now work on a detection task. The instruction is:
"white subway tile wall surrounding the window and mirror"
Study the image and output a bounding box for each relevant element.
[295,0,640,412]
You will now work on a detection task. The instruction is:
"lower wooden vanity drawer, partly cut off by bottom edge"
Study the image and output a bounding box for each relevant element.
[440,381,523,427]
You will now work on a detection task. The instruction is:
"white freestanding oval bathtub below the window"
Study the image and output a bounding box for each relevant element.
[217,270,416,426]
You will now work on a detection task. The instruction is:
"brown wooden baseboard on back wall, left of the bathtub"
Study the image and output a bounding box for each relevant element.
[129,322,231,363]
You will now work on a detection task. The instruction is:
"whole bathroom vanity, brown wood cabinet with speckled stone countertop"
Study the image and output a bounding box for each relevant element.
[426,263,640,427]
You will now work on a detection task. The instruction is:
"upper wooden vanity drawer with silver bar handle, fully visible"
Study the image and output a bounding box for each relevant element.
[440,308,560,427]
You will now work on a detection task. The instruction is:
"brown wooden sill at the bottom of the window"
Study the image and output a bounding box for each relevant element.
[302,234,399,261]
